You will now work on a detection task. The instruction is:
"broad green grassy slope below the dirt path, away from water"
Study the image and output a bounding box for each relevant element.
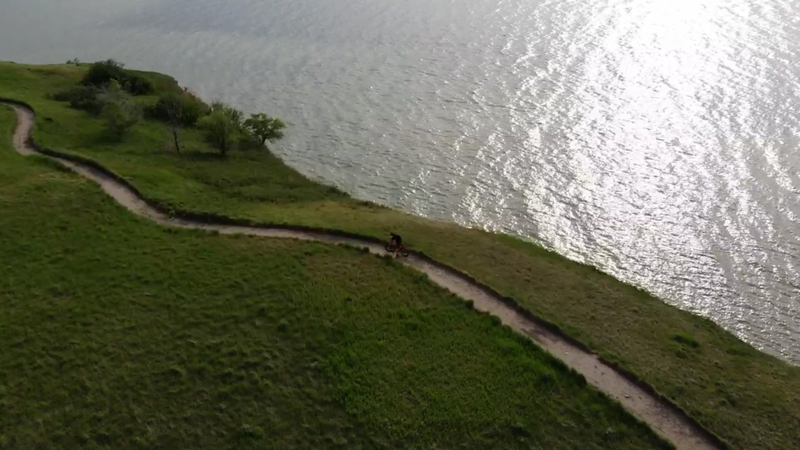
[0,106,670,450]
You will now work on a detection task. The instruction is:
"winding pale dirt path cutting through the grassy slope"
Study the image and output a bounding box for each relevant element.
[0,101,723,450]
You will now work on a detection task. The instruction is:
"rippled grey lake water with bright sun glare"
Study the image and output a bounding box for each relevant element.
[0,0,800,364]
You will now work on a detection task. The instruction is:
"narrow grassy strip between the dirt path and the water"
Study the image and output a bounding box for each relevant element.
[0,64,800,450]
